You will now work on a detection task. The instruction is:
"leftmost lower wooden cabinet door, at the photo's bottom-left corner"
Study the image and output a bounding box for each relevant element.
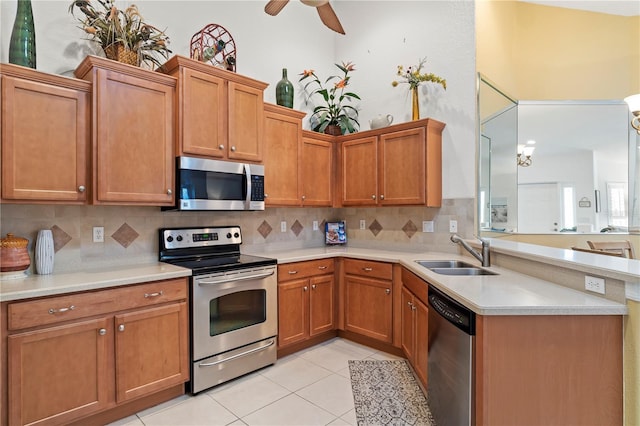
[7,318,113,425]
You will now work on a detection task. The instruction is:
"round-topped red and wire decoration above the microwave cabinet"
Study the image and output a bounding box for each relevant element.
[190,24,237,72]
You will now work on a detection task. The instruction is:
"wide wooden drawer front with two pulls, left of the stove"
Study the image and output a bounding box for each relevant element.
[8,278,187,330]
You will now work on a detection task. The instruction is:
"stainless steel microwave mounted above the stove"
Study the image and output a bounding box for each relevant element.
[169,157,264,210]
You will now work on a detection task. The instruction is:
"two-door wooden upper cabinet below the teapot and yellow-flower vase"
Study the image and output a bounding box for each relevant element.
[337,119,445,207]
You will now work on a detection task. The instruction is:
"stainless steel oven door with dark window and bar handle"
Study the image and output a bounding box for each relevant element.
[191,266,278,361]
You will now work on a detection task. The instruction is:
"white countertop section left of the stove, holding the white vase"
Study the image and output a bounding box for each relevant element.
[0,262,191,302]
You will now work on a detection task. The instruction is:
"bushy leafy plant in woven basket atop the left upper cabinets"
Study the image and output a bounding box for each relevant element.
[69,0,171,69]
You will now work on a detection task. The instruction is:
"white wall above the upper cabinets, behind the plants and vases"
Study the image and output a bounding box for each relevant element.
[0,0,476,198]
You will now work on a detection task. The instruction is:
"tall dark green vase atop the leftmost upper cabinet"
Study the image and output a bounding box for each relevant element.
[9,0,36,69]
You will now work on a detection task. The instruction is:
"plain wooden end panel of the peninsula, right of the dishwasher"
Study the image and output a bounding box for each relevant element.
[474,315,623,426]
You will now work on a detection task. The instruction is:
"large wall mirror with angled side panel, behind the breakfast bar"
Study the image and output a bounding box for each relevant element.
[478,74,636,237]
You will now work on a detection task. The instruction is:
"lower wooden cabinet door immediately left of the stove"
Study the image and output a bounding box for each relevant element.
[115,302,189,403]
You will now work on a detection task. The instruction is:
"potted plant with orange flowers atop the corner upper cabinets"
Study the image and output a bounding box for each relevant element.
[299,62,360,135]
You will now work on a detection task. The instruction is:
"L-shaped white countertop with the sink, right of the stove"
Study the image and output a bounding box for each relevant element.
[246,246,627,315]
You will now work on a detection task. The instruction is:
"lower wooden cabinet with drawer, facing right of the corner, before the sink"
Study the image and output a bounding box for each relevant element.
[344,259,394,344]
